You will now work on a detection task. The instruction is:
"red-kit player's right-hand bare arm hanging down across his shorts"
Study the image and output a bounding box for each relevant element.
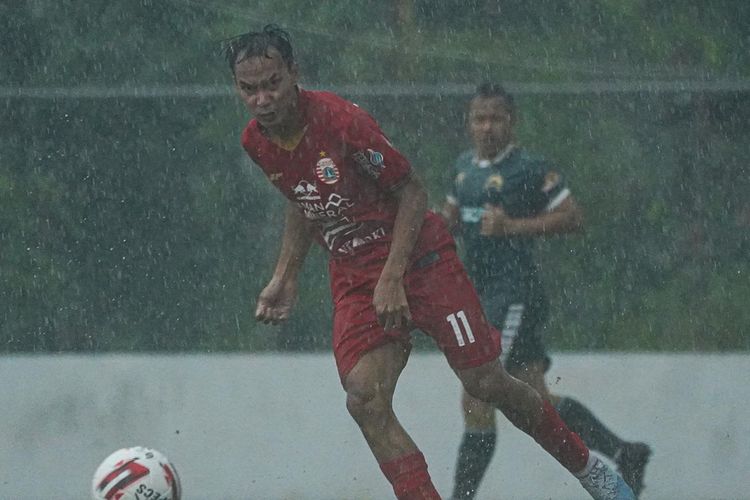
[372,173,427,329]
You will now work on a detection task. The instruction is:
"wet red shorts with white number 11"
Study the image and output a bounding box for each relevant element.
[329,247,500,380]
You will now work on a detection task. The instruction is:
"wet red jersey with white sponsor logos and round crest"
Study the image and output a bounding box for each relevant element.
[242,90,453,261]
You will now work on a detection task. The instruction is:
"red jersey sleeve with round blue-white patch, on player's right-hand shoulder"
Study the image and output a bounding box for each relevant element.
[345,111,412,191]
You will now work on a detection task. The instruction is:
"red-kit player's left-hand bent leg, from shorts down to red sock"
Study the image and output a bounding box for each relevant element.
[343,342,440,500]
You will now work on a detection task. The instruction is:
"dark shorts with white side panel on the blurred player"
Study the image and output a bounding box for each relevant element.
[482,291,552,373]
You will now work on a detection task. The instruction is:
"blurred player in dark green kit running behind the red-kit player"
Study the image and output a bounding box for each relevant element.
[443,84,651,500]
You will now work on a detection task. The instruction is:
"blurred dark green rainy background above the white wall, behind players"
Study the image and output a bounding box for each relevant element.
[0,0,750,353]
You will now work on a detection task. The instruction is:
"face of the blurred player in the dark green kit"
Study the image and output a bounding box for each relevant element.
[469,97,513,157]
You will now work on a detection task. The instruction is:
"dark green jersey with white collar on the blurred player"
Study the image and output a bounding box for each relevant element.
[448,146,569,294]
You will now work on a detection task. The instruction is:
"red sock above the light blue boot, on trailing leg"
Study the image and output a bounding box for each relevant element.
[532,401,589,474]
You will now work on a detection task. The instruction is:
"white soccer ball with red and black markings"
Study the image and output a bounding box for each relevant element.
[91,446,182,500]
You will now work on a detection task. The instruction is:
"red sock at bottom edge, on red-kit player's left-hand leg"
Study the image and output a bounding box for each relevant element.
[380,451,440,500]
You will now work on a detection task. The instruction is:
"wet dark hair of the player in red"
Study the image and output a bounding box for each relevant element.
[224,24,294,73]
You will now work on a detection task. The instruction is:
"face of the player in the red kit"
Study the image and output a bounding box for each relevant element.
[234,48,297,129]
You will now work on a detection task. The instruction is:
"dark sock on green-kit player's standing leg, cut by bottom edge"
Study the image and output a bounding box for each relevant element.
[453,431,497,500]
